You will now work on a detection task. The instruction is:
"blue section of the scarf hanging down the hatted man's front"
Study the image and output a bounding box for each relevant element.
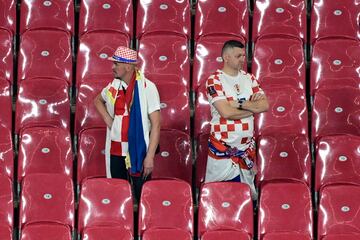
[128,81,147,174]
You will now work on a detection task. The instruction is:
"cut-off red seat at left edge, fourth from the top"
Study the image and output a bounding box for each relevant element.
[0,125,15,180]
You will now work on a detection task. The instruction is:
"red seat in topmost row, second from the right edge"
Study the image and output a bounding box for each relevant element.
[252,0,306,42]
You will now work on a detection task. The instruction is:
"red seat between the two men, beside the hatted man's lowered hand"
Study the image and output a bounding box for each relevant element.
[151,129,192,184]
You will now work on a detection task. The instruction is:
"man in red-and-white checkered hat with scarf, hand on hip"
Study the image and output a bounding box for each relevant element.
[94,46,160,199]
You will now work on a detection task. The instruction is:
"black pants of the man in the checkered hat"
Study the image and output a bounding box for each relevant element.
[110,155,149,202]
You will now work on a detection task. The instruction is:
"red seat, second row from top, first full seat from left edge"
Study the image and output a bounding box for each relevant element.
[18,30,72,85]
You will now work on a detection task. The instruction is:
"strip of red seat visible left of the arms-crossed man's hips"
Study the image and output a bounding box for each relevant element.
[195,133,209,188]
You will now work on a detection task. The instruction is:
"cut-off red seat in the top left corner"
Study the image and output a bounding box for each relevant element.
[0,0,17,36]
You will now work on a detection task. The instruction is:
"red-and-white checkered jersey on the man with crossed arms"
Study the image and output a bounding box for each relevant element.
[206,70,263,150]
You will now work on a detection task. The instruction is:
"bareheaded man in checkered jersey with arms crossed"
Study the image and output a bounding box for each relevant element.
[205,40,269,199]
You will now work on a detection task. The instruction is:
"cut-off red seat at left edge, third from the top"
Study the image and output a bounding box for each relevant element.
[0,78,12,129]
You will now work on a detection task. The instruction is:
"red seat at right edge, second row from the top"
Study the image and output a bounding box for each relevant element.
[310,38,360,95]
